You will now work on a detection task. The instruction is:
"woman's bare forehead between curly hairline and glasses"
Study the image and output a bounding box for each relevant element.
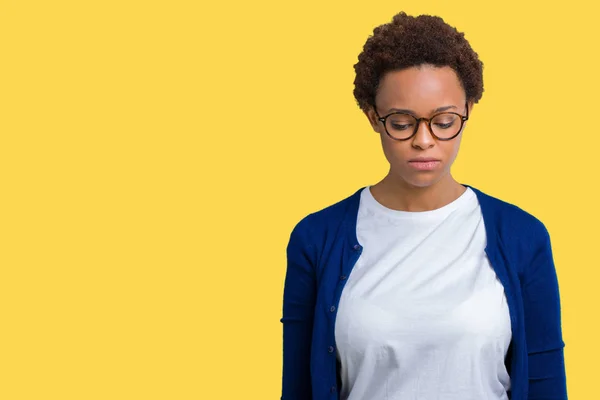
[376,65,465,110]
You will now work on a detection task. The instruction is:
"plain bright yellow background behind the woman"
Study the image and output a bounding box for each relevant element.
[0,0,600,400]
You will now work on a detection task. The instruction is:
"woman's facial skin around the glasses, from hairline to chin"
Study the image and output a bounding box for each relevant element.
[366,65,472,187]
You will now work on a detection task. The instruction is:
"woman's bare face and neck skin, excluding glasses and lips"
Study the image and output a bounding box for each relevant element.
[365,65,473,212]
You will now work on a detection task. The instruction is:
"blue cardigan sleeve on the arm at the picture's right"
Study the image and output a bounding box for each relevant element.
[522,222,567,400]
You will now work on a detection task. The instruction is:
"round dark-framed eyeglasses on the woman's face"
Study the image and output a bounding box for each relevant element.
[373,103,469,140]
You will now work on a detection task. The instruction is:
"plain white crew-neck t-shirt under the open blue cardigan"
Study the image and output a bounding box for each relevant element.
[335,187,511,400]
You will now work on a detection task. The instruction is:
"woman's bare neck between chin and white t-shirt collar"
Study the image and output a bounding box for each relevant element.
[371,174,466,212]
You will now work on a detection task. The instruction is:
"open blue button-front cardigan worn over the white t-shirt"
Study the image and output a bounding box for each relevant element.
[281,185,567,400]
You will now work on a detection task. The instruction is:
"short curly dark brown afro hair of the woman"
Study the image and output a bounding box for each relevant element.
[354,12,483,112]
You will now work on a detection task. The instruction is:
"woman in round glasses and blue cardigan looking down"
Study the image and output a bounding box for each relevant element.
[281,13,567,400]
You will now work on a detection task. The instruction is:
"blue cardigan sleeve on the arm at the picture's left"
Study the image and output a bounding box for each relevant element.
[281,219,316,400]
